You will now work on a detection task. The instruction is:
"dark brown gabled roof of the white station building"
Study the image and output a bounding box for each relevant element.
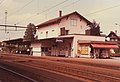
[36,11,91,28]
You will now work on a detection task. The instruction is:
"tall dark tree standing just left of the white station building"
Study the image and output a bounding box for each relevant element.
[24,23,36,41]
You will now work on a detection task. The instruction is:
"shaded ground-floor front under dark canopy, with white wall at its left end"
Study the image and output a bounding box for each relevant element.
[32,37,73,57]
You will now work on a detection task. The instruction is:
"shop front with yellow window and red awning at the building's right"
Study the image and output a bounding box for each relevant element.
[78,41,118,58]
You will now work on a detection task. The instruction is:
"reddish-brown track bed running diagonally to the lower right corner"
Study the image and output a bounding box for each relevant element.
[15,61,120,82]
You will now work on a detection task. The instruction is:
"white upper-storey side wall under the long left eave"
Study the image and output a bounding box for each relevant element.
[36,24,60,39]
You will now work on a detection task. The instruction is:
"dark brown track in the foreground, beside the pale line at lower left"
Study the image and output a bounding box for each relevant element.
[0,61,85,82]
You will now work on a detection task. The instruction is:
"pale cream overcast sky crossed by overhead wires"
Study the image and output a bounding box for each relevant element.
[0,0,120,41]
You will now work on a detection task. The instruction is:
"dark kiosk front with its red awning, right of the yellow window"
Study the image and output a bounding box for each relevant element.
[91,42,118,58]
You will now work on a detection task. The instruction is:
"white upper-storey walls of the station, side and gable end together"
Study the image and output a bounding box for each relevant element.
[36,14,89,39]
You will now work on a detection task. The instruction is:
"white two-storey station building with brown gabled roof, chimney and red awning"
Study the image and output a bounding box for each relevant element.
[31,11,118,58]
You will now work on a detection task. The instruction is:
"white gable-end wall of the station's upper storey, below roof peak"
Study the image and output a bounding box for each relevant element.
[59,14,89,34]
